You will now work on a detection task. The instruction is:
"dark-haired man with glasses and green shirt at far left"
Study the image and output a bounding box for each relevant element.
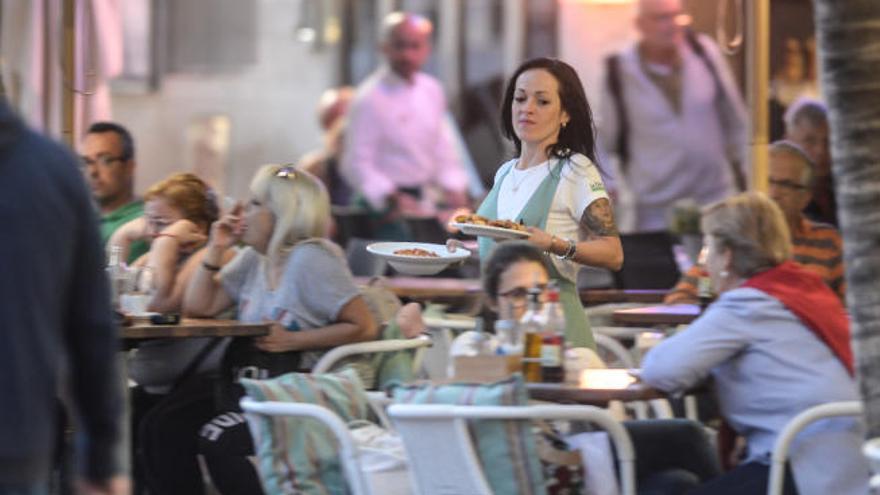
[80,122,150,262]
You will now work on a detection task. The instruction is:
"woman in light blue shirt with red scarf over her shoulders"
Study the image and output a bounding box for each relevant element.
[642,192,868,494]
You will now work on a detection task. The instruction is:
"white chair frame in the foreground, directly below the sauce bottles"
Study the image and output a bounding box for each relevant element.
[388,404,636,495]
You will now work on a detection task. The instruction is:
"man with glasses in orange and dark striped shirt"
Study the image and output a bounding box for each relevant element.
[664,141,846,304]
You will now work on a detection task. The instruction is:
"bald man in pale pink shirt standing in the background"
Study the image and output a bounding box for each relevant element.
[341,12,468,240]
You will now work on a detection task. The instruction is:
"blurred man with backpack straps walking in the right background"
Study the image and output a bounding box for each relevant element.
[598,0,747,232]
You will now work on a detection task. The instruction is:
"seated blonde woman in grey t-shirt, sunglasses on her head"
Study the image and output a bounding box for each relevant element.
[136,165,379,495]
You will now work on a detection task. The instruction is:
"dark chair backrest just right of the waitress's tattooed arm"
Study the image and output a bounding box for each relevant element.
[614,231,680,289]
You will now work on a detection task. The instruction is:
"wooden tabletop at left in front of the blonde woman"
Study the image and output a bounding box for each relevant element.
[120,318,269,340]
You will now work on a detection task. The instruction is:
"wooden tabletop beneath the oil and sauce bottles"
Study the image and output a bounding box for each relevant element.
[526,369,665,407]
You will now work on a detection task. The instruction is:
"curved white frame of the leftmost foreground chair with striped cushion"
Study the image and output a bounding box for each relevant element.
[240,397,372,495]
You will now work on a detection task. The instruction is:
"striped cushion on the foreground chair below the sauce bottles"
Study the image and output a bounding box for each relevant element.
[393,373,547,495]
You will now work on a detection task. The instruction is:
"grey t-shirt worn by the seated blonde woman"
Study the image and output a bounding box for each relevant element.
[220,239,359,368]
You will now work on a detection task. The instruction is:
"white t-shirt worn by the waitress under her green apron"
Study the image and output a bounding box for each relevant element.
[495,154,608,281]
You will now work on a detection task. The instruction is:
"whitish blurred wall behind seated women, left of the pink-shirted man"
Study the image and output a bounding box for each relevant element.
[113,0,337,199]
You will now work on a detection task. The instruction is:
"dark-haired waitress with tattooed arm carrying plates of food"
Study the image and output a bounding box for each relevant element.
[477,58,623,348]
